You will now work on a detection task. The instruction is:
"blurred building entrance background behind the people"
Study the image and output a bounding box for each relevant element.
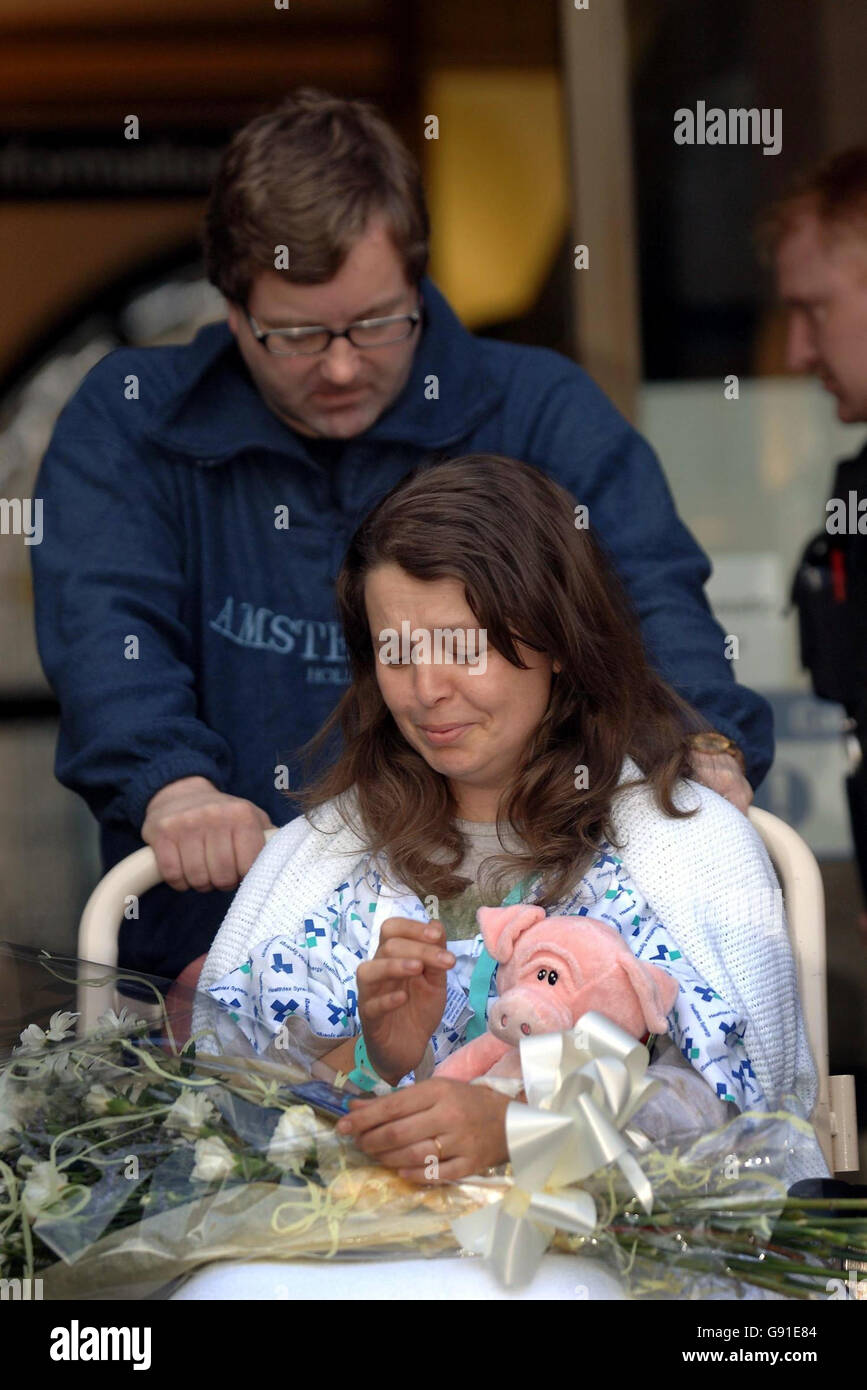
[0,0,867,1173]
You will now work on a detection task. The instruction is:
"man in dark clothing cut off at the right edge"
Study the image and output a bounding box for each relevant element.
[761,146,867,931]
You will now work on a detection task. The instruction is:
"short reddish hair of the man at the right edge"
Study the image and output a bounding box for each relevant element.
[757,145,867,259]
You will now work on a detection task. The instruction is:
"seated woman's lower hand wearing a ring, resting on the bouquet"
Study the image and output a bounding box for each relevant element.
[338,1077,511,1183]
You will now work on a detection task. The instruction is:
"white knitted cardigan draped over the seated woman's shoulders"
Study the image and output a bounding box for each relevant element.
[193,759,828,1184]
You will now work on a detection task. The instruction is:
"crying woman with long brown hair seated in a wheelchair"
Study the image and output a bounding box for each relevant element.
[195,456,827,1182]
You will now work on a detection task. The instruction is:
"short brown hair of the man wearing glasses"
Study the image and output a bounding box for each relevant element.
[204,88,429,304]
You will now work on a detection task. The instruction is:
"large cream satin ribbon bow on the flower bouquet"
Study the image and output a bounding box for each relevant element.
[452,1013,659,1287]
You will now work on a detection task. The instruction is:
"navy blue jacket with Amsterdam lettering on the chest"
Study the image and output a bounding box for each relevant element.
[31,279,773,973]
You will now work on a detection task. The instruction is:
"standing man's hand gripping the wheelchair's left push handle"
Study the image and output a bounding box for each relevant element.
[142,777,271,892]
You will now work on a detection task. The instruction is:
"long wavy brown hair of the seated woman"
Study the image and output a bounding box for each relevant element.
[299,455,709,908]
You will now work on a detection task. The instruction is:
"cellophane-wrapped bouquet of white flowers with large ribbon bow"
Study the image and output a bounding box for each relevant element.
[0,956,867,1298]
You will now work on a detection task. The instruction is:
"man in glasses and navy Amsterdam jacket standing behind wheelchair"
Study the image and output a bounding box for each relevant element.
[33,90,773,974]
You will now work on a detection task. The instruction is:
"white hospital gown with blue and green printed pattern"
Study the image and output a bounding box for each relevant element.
[210,845,763,1109]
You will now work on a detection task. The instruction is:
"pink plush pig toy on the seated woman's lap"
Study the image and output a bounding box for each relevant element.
[436,902,678,1081]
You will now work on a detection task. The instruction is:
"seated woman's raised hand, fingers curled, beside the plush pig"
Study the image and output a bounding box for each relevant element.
[356,917,454,1086]
